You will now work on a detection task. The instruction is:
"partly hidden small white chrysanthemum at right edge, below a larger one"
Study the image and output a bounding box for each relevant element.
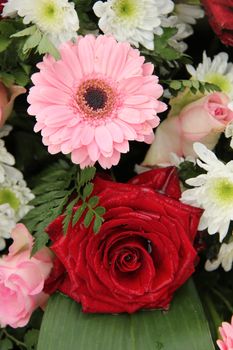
[205,242,233,272]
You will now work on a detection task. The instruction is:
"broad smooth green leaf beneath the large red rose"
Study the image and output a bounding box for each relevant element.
[37,280,214,350]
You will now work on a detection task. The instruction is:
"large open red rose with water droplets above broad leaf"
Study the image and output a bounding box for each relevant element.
[46,168,201,313]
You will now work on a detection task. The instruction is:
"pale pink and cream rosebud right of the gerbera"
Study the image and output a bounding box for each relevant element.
[143,92,233,166]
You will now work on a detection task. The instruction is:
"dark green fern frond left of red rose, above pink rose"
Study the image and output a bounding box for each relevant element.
[23,161,77,255]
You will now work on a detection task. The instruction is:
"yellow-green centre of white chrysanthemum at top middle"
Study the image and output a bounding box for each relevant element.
[112,0,140,20]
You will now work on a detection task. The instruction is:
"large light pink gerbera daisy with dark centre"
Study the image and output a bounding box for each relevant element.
[28,35,166,168]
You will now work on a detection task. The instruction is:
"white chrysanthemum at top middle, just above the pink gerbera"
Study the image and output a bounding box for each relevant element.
[93,0,174,50]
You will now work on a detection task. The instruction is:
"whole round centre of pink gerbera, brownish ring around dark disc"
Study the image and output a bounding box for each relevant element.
[76,79,116,118]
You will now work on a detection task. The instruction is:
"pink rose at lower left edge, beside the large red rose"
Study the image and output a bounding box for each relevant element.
[0,224,53,328]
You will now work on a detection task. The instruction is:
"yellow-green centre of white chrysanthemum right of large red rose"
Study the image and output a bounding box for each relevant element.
[211,178,233,205]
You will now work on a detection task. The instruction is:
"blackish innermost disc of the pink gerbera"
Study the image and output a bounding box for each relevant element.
[84,87,108,111]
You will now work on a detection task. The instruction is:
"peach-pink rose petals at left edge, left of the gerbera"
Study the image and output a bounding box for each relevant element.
[0,81,26,128]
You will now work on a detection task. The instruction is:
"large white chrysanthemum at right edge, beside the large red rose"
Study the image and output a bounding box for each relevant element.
[181,143,233,242]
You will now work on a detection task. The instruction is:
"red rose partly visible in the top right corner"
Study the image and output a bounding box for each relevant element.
[202,0,233,46]
